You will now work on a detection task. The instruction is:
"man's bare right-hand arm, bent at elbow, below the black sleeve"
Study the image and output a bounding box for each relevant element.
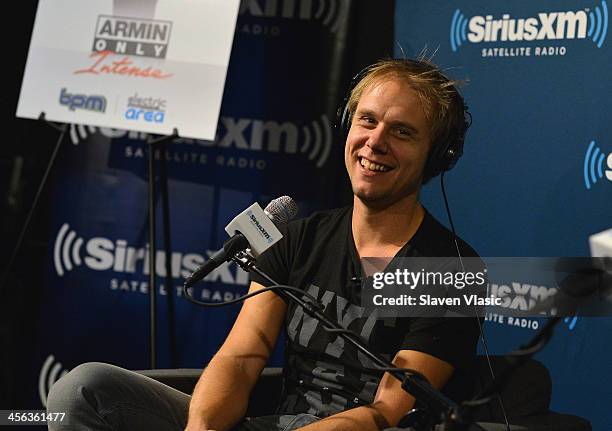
[292,350,454,431]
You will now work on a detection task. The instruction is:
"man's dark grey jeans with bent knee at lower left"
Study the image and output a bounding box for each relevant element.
[47,362,319,431]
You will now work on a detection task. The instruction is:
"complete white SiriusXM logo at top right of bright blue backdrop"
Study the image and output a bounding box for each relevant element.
[450,0,608,51]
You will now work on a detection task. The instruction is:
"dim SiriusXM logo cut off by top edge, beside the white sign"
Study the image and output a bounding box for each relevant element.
[240,0,348,33]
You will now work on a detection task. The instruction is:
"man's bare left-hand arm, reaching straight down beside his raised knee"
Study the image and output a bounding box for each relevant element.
[186,282,287,431]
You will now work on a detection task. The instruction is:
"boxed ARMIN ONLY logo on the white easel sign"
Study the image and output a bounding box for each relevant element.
[92,15,172,59]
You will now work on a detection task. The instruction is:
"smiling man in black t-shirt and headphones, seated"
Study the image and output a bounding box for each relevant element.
[48,59,478,431]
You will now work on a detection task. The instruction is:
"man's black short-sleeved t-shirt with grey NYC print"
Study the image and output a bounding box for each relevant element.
[252,207,479,417]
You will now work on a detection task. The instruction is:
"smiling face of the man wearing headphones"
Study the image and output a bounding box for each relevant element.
[344,78,431,207]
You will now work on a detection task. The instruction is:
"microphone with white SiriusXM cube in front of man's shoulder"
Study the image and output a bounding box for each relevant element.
[185,196,298,288]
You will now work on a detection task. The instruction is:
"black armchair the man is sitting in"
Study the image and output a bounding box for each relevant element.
[138,356,591,431]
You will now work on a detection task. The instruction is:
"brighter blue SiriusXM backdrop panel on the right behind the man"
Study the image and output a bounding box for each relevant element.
[395,0,612,431]
